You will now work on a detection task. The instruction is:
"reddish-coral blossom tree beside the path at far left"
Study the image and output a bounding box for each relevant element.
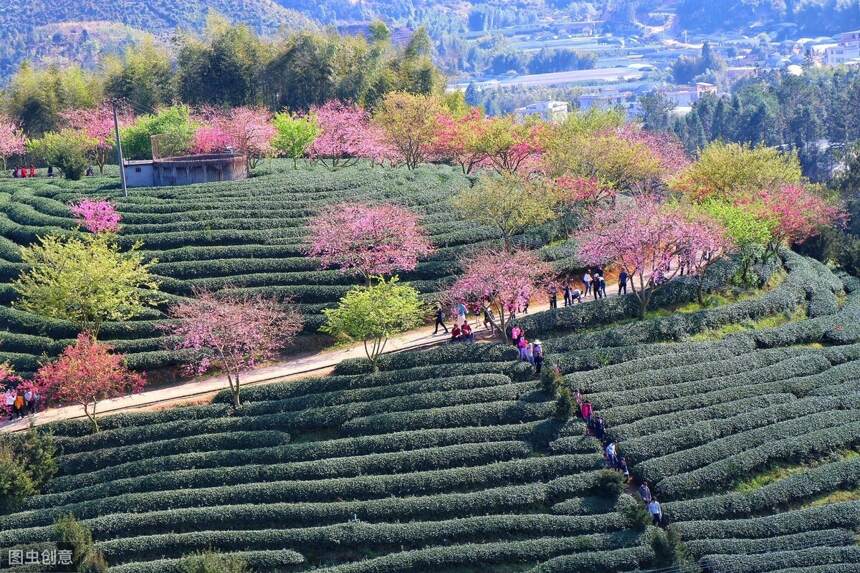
[36,332,146,432]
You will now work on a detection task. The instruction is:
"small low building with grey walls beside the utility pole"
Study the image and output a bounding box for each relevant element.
[123,153,248,187]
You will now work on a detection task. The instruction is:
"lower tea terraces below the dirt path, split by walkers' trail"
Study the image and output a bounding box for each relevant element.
[0,252,860,573]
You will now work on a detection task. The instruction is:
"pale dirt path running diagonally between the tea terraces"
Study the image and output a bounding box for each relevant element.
[0,278,617,432]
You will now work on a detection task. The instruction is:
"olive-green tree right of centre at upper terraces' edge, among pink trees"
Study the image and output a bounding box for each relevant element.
[453,175,556,251]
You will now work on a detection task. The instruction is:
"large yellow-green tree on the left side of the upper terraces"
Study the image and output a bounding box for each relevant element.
[13,233,158,336]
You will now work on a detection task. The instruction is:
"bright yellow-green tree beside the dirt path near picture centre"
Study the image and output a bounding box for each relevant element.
[320,276,427,371]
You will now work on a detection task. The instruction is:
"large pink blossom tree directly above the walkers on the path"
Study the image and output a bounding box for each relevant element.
[577,196,724,318]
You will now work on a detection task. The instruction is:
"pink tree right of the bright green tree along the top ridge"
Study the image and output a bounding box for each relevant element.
[308,100,384,170]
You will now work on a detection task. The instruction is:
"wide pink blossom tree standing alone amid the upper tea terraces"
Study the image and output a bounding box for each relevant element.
[308,203,433,285]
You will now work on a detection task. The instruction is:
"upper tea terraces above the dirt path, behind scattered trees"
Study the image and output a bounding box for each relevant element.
[0,161,572,373]
